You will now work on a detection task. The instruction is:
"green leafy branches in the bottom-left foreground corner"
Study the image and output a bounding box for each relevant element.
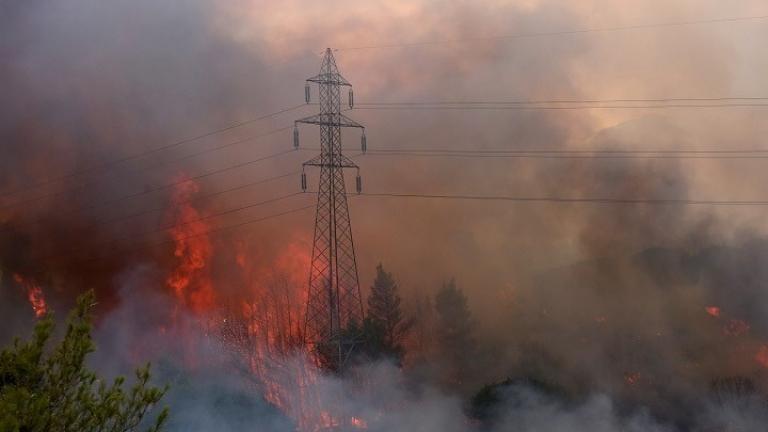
[0,292,168,432]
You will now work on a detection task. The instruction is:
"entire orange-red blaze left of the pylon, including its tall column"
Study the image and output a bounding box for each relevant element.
[159,182,352,432]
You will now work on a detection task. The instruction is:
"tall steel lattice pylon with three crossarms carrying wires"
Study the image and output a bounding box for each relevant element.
[294,48,366,371]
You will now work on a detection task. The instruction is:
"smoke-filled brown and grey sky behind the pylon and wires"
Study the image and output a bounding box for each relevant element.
[0,0,768,430]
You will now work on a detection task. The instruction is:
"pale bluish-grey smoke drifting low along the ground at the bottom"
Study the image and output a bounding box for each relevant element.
[94,274,768,432]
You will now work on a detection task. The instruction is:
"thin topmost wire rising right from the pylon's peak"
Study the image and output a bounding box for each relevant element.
[337,15,768,51]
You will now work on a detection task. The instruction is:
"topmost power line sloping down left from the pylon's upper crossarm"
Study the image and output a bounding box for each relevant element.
[0,104,306,198]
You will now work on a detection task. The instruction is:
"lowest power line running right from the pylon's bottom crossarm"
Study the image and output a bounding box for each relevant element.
[352,192,768,206]
